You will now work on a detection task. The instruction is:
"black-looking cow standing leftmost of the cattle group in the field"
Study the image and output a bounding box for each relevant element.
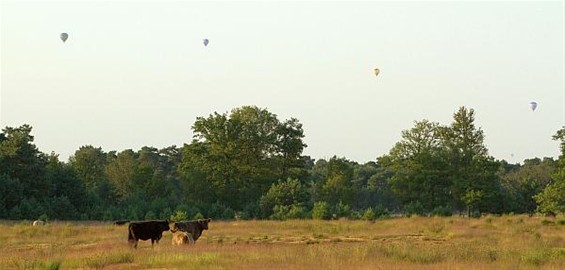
[128,220,170,247]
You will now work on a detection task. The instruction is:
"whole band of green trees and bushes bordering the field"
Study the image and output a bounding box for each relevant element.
[0,106,565,220]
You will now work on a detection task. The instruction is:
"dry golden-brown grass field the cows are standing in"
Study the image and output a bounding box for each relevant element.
[0,216,565,269]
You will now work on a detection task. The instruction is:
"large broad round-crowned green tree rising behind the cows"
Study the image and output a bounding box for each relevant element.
[181,106,305,210]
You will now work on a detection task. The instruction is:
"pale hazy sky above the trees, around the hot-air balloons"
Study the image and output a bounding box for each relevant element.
[0,0,565,163]
